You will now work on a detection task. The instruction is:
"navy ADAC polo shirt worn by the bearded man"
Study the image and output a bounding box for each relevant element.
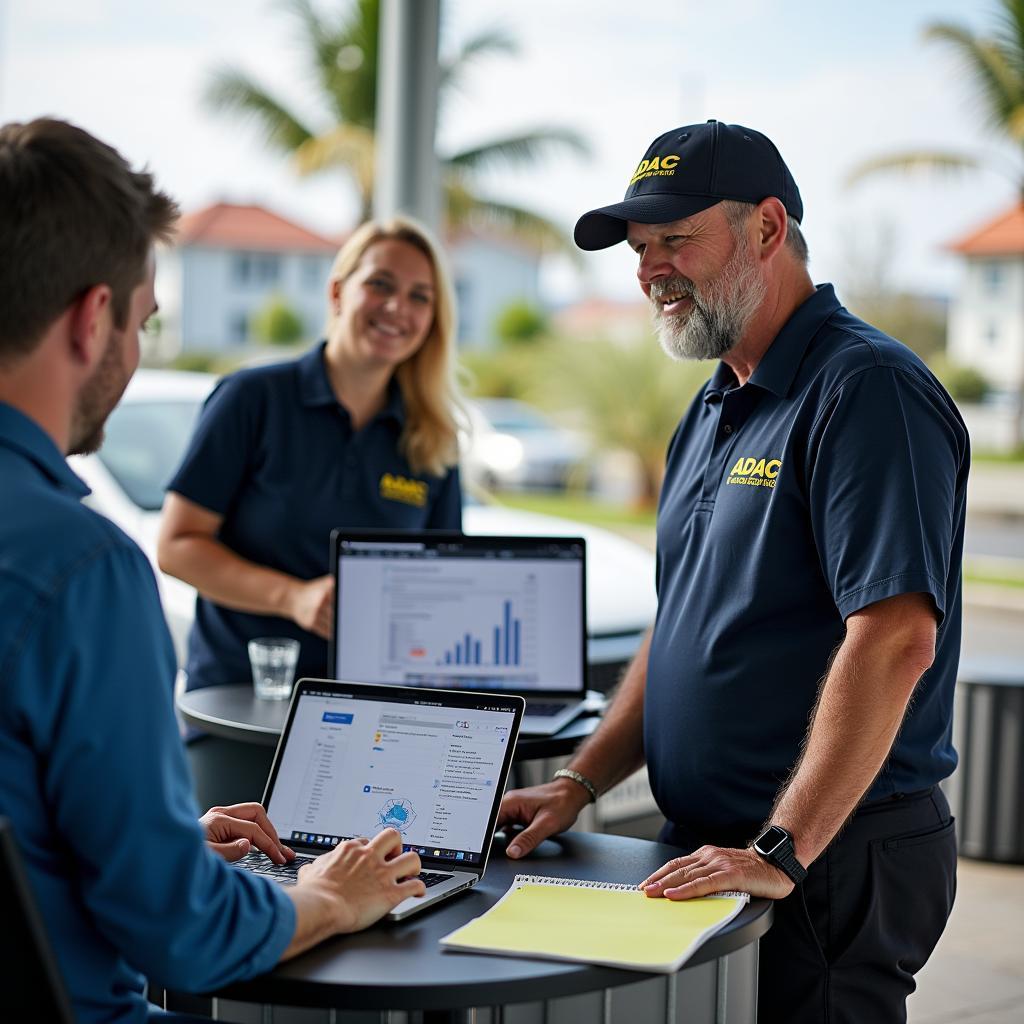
[644,286,970,828]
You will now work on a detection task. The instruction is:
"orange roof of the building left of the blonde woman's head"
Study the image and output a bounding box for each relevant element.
[175,203,338,253]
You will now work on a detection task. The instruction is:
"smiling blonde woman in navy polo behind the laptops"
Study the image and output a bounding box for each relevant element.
[159,218,462,712]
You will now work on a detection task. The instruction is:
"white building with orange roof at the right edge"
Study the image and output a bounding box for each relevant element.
[946,204,1024,391]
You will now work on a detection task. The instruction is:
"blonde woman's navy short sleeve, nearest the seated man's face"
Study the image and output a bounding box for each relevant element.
[167,374,261,516]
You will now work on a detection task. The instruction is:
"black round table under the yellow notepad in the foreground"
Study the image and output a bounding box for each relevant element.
[205,833,772,1024]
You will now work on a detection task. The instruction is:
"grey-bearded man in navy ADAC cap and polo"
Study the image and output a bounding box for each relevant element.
[502,121,970,1024]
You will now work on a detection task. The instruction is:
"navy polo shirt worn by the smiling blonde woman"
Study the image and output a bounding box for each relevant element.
[169,343,462,689]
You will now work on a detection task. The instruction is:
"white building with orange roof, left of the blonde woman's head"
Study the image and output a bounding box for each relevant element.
[157,203,338,358]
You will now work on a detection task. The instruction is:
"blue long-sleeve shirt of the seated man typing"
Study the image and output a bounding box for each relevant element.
[0,402,295,1022]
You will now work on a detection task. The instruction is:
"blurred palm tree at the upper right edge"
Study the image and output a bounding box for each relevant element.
[847,0,1024,446]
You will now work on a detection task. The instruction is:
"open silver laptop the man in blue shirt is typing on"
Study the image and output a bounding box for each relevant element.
[238,679,523,921]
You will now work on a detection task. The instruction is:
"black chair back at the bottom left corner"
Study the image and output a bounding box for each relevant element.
[0,817,75,1024]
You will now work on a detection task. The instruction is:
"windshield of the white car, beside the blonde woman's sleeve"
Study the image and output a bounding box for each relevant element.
[98,398,203,512]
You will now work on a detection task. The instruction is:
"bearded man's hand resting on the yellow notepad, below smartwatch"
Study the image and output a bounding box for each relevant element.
[640,846,794,899]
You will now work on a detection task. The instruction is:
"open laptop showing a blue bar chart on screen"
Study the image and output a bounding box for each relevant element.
[329,529,587,736]
